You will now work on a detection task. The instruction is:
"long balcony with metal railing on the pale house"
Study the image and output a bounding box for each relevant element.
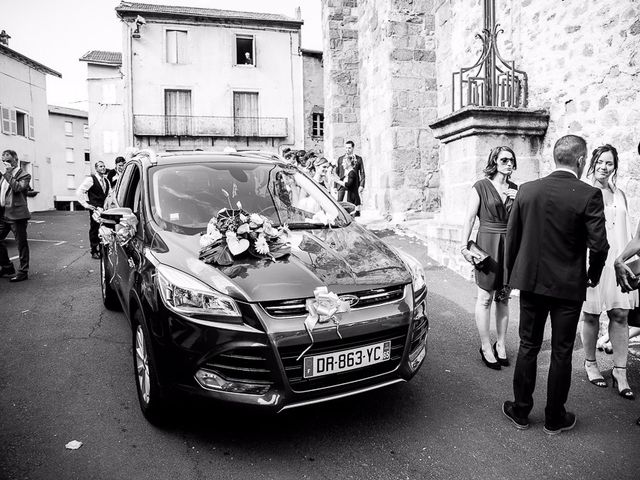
[133,115,288,138]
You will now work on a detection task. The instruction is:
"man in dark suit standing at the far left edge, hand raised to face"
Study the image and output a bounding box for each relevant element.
[0,150,31,282]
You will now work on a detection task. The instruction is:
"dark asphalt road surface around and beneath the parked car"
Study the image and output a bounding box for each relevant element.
[0,212,640,480]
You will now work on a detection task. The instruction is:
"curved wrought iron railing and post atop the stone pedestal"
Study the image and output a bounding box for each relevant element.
[451,0,528,111]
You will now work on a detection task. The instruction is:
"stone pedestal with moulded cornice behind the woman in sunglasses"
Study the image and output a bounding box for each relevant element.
[426,106,549,277]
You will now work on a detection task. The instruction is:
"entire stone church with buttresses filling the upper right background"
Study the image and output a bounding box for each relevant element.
[323,0,640,269]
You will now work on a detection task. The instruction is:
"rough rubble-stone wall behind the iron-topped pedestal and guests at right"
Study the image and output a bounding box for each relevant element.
[435,0,640,218]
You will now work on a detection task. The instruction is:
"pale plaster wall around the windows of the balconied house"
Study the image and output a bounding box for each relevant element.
[123,18,304,148]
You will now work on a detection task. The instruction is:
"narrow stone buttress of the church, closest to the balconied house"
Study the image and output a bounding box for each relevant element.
[322,0,361,160]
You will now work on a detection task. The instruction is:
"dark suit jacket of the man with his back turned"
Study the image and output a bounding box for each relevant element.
[505,171,609,301]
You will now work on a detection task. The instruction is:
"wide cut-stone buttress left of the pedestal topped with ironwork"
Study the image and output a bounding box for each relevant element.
[359,0,439,213]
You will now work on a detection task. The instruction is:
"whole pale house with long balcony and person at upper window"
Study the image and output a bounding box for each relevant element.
[116,2,304,151]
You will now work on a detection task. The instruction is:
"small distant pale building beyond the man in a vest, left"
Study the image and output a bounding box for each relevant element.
[49,105,91,210]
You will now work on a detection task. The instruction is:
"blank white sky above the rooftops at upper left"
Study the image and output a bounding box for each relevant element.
[0,0,322,109]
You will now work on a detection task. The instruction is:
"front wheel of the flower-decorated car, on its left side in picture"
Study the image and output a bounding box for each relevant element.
[132,310,168,426]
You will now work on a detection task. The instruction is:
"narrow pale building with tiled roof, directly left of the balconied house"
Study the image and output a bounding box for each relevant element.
[80,50,130,168]
